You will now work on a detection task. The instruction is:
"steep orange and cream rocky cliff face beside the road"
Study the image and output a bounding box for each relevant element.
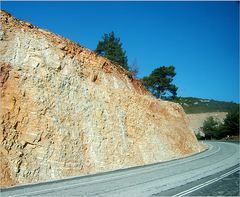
[0,11,199,186]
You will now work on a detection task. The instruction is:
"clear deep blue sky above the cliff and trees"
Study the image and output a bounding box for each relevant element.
[1,2,239,102]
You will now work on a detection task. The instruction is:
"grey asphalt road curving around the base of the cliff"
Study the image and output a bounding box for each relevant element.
[1,142,240,197]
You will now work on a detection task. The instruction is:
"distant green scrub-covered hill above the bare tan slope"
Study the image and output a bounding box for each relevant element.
[171,97,239,114]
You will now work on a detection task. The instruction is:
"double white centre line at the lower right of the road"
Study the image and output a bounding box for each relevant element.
[173,167,240,197]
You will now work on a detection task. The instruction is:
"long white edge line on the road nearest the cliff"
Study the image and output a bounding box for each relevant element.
[9,144,220,197]
